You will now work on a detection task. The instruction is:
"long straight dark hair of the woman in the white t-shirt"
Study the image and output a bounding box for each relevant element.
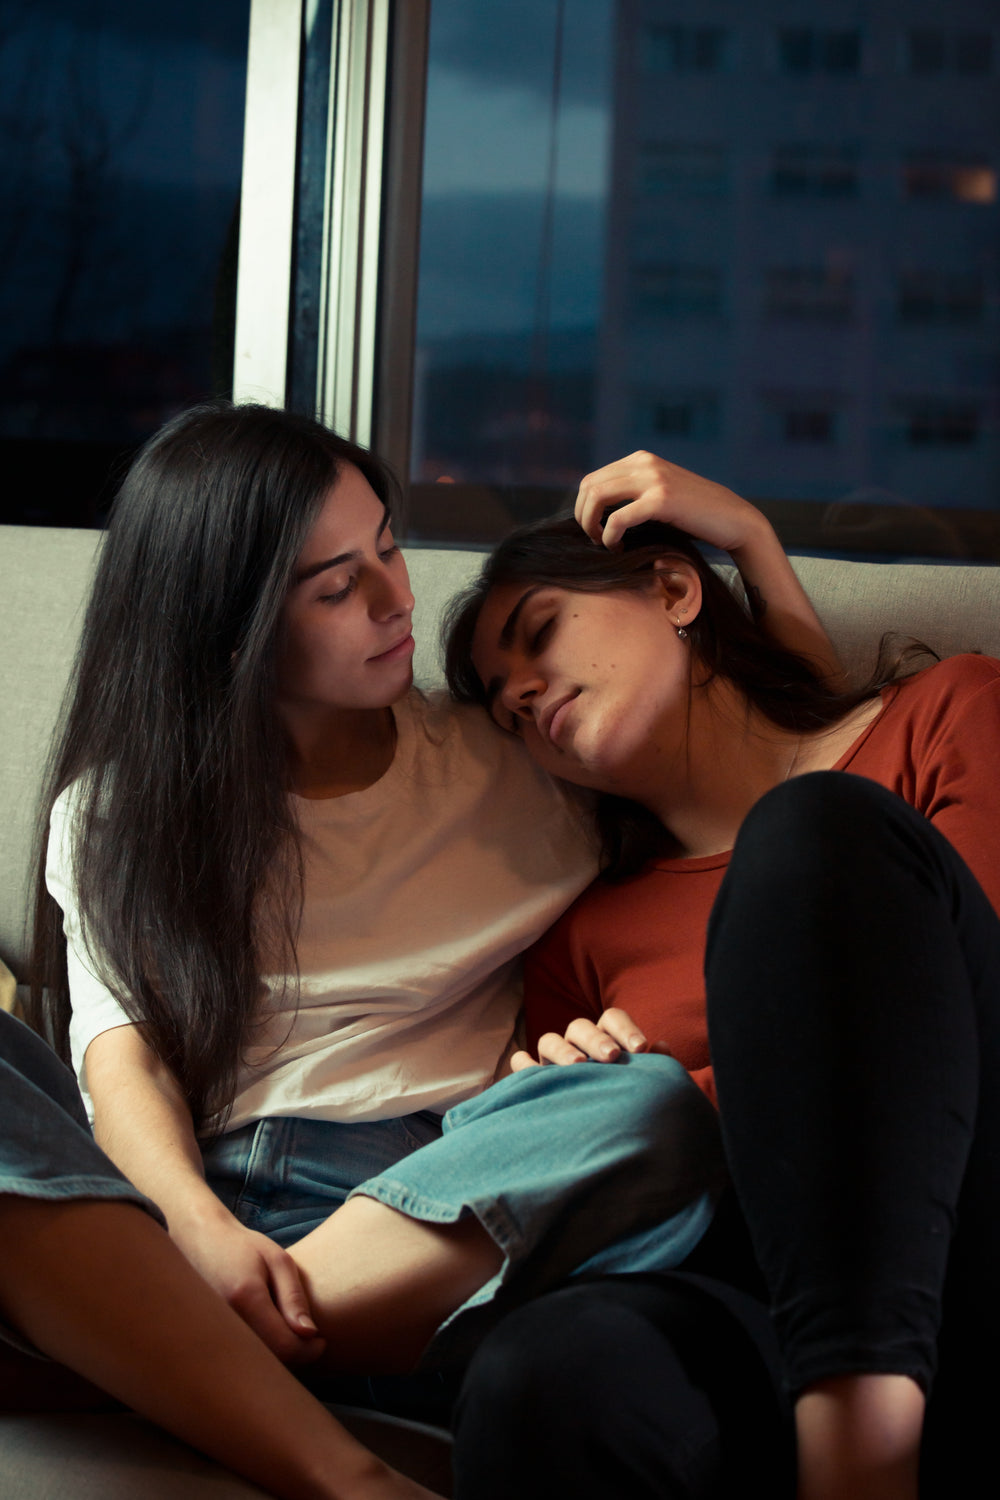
[30,404,394,1127]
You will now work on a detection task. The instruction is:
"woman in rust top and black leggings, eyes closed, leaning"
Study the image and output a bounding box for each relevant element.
[451,494,1000,1500]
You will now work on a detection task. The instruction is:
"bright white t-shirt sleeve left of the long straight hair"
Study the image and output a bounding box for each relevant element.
[45,786,132,1113]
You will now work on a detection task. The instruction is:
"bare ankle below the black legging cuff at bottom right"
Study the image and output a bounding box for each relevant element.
[795,1376,925,1500]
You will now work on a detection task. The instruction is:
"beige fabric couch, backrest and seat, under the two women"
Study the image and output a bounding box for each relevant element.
[0,527,1000,1500]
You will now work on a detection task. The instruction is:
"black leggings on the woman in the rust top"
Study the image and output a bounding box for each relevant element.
[457,773,1000,1500]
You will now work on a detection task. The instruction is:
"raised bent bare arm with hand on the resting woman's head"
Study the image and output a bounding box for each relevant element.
[576,452,844,687]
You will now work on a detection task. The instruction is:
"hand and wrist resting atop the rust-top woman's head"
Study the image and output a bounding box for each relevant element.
[574,452,771,552]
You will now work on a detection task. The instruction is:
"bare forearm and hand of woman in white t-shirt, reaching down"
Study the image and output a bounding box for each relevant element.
[87,1026,322,1361]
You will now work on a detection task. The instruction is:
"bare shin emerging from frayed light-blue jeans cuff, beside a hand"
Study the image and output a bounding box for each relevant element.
[289,1197,502,1374]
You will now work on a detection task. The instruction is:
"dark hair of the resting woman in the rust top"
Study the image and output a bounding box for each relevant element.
[445,516,927,881]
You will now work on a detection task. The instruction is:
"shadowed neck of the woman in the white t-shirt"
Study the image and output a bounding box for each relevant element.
[280,705,396,800]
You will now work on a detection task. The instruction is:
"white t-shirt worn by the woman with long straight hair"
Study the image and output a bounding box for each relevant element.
[46,693,595,1130]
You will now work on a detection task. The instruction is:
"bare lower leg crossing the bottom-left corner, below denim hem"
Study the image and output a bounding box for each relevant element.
[0,1196,433,1500]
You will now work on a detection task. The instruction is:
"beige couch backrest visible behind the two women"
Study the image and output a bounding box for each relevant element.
[0,527,1000,972]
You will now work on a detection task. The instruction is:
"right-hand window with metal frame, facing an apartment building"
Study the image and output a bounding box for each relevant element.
[226,0,1000,557]
